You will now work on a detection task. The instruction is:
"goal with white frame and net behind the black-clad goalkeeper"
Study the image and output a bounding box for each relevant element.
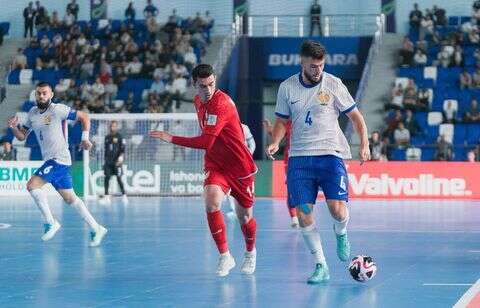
[83,113,204,198]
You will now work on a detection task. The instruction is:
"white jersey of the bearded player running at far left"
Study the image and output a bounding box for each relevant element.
[23,103,77,166]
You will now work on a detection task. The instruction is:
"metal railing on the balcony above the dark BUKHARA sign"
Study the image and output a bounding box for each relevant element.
[245,14,378,37]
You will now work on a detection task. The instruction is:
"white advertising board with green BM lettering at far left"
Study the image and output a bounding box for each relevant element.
[0,161,56,196]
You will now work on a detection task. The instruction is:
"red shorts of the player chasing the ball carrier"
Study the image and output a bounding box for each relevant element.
[203,170,255,208]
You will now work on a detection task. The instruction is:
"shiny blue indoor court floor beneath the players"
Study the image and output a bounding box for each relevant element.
[0,197,480,307]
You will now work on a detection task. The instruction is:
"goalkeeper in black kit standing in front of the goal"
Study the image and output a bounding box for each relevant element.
[100,121,128,204]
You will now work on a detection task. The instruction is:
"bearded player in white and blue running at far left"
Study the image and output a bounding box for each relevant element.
[8,82,107,247]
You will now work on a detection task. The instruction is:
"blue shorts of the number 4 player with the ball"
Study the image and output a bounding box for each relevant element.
[287,155,348,207]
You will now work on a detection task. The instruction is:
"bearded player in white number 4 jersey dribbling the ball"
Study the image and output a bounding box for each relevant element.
[266,41,370,284]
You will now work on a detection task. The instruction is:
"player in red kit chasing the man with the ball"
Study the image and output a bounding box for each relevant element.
[150,64,257,276]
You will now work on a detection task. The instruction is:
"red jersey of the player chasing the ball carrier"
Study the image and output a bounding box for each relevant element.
[194,90,257,178]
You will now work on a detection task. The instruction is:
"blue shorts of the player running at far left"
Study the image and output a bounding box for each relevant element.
[34,159,73,190]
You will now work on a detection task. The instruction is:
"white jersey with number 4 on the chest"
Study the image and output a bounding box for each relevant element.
[275,72,356,159]
